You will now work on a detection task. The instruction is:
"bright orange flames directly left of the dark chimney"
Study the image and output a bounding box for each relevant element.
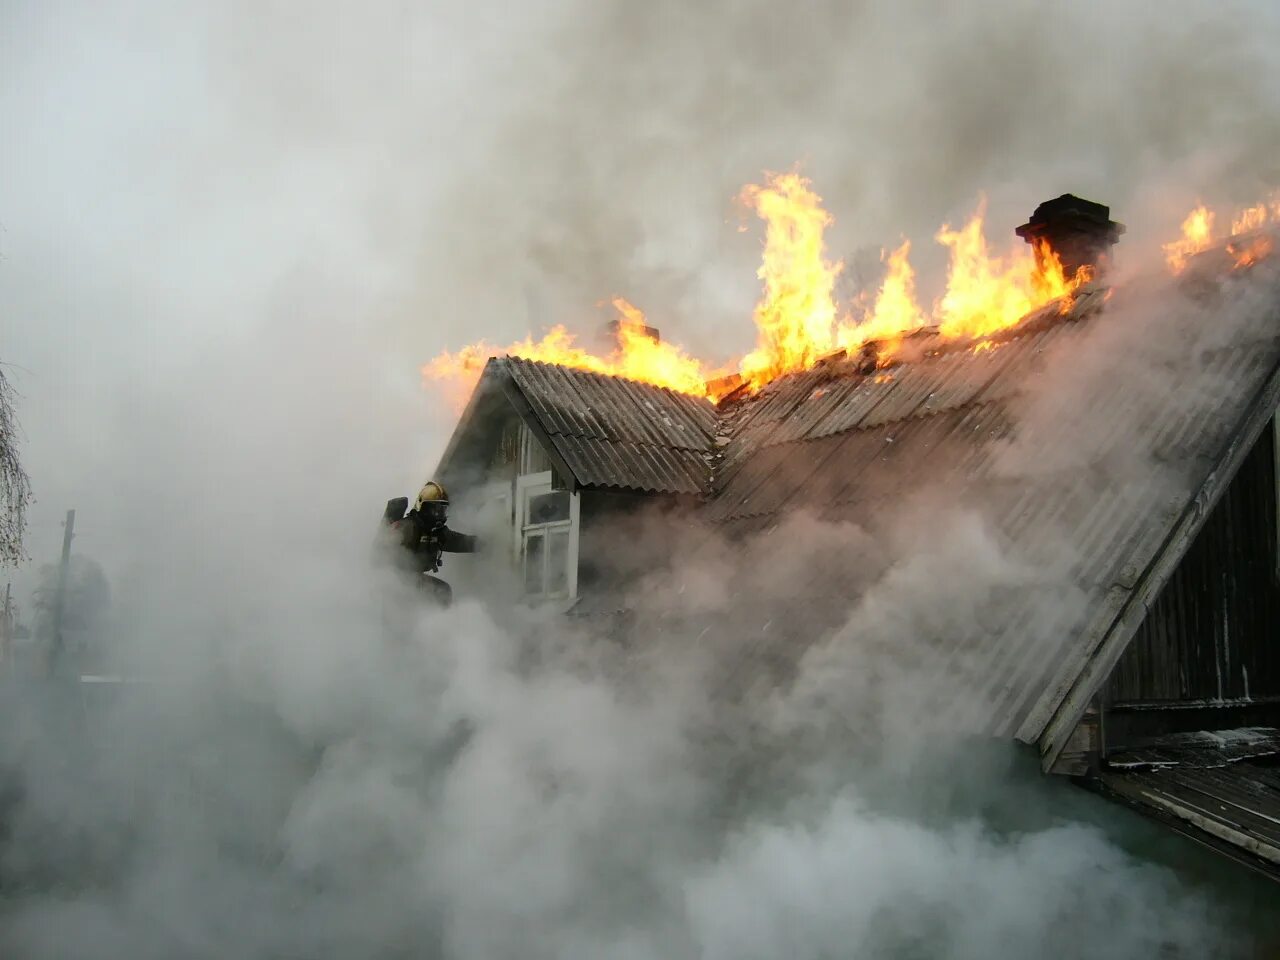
[933,198,1092,339]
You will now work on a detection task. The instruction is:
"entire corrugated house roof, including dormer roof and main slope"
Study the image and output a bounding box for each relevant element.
[435,239,1280,769]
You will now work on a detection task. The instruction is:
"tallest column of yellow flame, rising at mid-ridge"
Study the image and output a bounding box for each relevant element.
[740,173,844,389]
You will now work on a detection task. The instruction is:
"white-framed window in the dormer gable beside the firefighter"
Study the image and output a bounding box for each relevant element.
[516,471,577,599]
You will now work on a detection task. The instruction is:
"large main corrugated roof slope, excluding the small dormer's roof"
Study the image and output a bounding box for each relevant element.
[704,273,1280,768]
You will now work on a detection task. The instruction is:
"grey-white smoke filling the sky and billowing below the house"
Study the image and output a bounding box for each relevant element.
[0,0,1280,957]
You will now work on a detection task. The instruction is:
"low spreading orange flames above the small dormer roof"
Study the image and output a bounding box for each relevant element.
[422,297,724,407]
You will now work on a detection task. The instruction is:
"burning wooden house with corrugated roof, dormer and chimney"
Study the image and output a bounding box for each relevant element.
[424,184,1280,878]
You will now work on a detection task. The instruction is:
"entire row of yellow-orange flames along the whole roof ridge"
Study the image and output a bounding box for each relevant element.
[422,172,1280,404]
